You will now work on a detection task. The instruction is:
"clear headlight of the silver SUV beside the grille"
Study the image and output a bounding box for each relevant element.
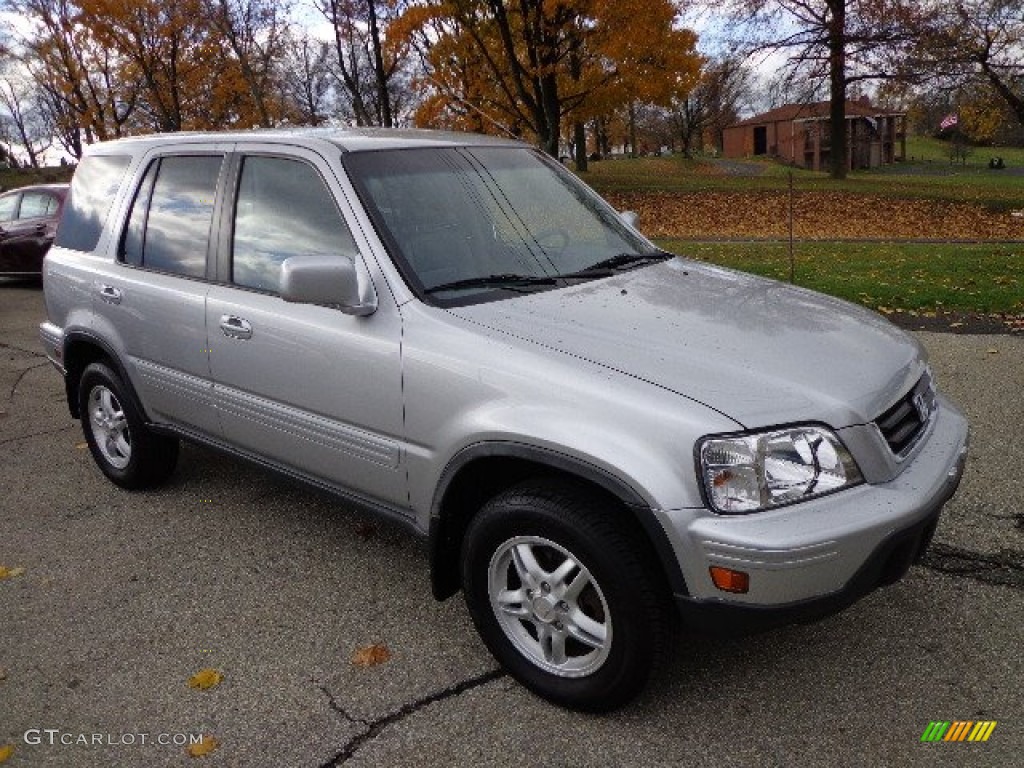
[699,426,863,514]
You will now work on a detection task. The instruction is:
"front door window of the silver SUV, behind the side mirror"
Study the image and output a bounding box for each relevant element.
[231,157,355,293]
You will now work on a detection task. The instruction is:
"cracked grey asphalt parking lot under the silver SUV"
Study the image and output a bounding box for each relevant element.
[0,280,1024,768]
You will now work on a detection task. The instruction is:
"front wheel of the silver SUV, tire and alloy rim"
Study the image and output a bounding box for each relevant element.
[462,481,671,712]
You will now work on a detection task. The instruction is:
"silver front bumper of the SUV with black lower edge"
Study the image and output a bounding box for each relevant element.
[662,397,968,628]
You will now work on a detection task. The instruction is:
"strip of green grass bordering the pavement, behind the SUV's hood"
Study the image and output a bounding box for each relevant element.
[658,241,1024,314]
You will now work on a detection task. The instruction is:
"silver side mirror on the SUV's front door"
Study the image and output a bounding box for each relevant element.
[281,253,377,316]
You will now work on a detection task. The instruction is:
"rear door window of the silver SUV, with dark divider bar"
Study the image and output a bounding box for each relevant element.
[121,155,223,278]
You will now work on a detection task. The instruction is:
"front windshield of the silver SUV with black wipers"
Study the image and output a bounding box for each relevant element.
[345,146,666,305]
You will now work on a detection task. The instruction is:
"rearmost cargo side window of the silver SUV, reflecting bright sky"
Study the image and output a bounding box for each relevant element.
[54,155,131,251]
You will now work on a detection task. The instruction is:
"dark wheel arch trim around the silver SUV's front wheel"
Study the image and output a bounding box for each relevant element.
[428,440,689,600]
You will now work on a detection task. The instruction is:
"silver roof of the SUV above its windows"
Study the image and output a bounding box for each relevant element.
[80,127,526,154]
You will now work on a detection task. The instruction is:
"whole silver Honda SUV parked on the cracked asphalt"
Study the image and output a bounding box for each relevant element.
[41,130,968,711]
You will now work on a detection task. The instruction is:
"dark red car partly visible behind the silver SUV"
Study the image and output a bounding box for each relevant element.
[0,184,68,275]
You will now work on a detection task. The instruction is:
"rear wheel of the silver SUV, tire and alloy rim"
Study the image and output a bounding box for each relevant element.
[78,362,178,490]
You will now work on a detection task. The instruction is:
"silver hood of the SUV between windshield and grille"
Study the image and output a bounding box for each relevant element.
[447,258,926,428]
